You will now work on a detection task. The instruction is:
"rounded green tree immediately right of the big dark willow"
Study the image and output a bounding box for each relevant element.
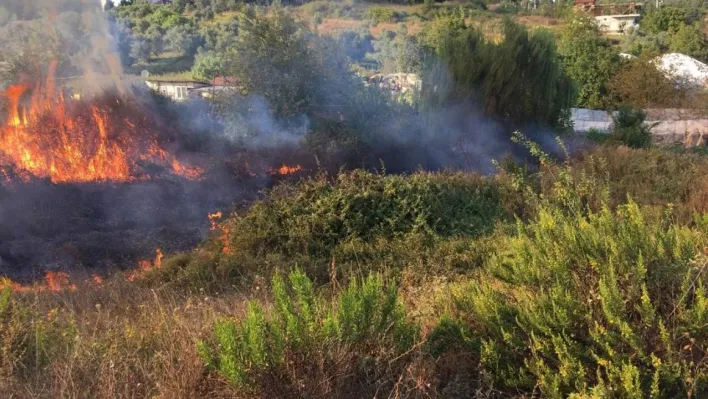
[560,18,620,109]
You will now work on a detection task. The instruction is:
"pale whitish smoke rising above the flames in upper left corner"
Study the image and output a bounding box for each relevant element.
[0,0,126,93]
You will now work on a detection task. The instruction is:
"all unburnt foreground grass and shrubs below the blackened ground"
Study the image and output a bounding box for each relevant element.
[0,141,708,397]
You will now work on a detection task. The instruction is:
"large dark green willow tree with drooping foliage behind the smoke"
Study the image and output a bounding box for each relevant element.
[422,17,574,126]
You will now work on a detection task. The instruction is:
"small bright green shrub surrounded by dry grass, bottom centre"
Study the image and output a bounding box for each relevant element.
[199,270,419,387]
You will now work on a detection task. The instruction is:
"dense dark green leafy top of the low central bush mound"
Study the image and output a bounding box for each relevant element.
[213,171,504,258]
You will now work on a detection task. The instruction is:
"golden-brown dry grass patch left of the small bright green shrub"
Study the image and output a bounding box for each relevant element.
[2,277,258,399]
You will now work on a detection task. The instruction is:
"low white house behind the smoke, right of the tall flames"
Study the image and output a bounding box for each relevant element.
[145,77,238,101]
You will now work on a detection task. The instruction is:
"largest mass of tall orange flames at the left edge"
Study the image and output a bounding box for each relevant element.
[0,65,203,183]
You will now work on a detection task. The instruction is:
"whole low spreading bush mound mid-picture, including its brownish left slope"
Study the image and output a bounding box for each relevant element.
[146,170,511,288]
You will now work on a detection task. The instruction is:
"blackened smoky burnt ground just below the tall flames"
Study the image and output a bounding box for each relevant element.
[0,178,258,281]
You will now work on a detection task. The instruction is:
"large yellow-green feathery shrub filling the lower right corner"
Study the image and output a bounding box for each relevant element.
[439,202,708,398]
